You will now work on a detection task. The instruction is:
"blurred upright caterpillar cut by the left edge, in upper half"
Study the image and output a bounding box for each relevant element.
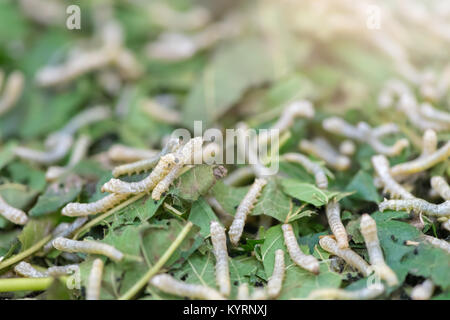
[0,70,25,116]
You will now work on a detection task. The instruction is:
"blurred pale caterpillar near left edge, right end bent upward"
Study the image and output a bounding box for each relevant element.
[14,134,73,165]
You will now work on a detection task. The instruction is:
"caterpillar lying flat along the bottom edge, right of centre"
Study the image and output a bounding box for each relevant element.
[307,283,384,300]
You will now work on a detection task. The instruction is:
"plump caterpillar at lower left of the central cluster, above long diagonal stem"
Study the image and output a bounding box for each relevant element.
[61,193,128,217]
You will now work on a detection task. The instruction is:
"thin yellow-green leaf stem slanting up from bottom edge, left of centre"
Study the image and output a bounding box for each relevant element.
[119,221,193,300]
